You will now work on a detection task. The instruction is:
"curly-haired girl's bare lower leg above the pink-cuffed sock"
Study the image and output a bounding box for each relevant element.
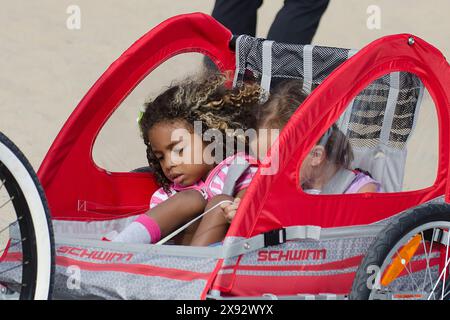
[147,190,206,237]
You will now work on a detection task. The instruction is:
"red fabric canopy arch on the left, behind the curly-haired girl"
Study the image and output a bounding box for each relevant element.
[38,13,235,221]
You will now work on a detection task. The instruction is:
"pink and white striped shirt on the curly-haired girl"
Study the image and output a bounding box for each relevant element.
[150,153,258,209]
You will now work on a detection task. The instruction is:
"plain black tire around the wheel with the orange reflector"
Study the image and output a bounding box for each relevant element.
[349,203,450,300]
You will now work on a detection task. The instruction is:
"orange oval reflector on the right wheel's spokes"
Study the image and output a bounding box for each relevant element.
[381,234,422,287]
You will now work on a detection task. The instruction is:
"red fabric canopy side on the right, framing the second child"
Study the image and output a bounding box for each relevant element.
[228,34,450,237]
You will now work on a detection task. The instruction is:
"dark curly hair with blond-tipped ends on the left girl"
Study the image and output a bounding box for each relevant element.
[139,73,262,192]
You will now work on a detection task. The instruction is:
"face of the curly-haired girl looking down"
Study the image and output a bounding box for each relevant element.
[148,120,214,187]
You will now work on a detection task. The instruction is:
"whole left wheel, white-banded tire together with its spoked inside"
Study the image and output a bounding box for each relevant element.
[0,132,54,299]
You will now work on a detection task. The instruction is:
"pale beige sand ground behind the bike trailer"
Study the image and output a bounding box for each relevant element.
[0,0,450,189]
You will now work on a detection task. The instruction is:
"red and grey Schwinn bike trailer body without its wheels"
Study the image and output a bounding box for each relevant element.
[29,13,450,299]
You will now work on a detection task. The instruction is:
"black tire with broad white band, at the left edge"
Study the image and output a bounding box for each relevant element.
[0,132,55,300]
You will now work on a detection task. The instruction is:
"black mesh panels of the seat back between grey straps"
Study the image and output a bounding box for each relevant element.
[236,36,423,149]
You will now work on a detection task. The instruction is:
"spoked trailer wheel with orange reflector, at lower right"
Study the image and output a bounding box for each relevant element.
[349,203,450,300]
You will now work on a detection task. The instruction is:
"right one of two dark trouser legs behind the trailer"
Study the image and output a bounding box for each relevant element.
[267,0,329,44]
